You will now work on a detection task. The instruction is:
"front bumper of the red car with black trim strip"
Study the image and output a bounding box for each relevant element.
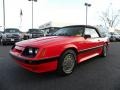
[10,51,57,73]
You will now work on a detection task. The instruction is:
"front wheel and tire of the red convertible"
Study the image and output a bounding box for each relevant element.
[57,50,76,75]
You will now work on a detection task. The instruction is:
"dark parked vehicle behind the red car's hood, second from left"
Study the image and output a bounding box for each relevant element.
[24,28,44,39]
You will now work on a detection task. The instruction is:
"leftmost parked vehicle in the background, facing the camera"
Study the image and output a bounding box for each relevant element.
[1,28,22,45]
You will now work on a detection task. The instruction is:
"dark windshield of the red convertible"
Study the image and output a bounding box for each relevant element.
[52,27,84,36]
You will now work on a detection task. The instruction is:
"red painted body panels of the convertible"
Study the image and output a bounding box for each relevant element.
[10,36,108,73]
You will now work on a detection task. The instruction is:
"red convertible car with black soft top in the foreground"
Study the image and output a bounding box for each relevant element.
[10,25,109,75]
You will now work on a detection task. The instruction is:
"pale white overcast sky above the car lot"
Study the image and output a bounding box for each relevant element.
[0,0,120,31]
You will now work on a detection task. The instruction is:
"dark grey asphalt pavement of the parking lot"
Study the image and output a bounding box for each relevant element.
[0,42,120,90]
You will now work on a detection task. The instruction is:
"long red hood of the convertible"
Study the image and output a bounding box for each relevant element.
[16,36,80,47]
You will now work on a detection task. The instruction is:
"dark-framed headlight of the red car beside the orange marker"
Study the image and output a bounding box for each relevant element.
[22,47,38,57]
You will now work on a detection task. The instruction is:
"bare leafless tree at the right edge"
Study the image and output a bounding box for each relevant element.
[100,5,120,28]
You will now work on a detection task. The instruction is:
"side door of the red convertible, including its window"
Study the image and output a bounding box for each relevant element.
[79,27,102,62]
